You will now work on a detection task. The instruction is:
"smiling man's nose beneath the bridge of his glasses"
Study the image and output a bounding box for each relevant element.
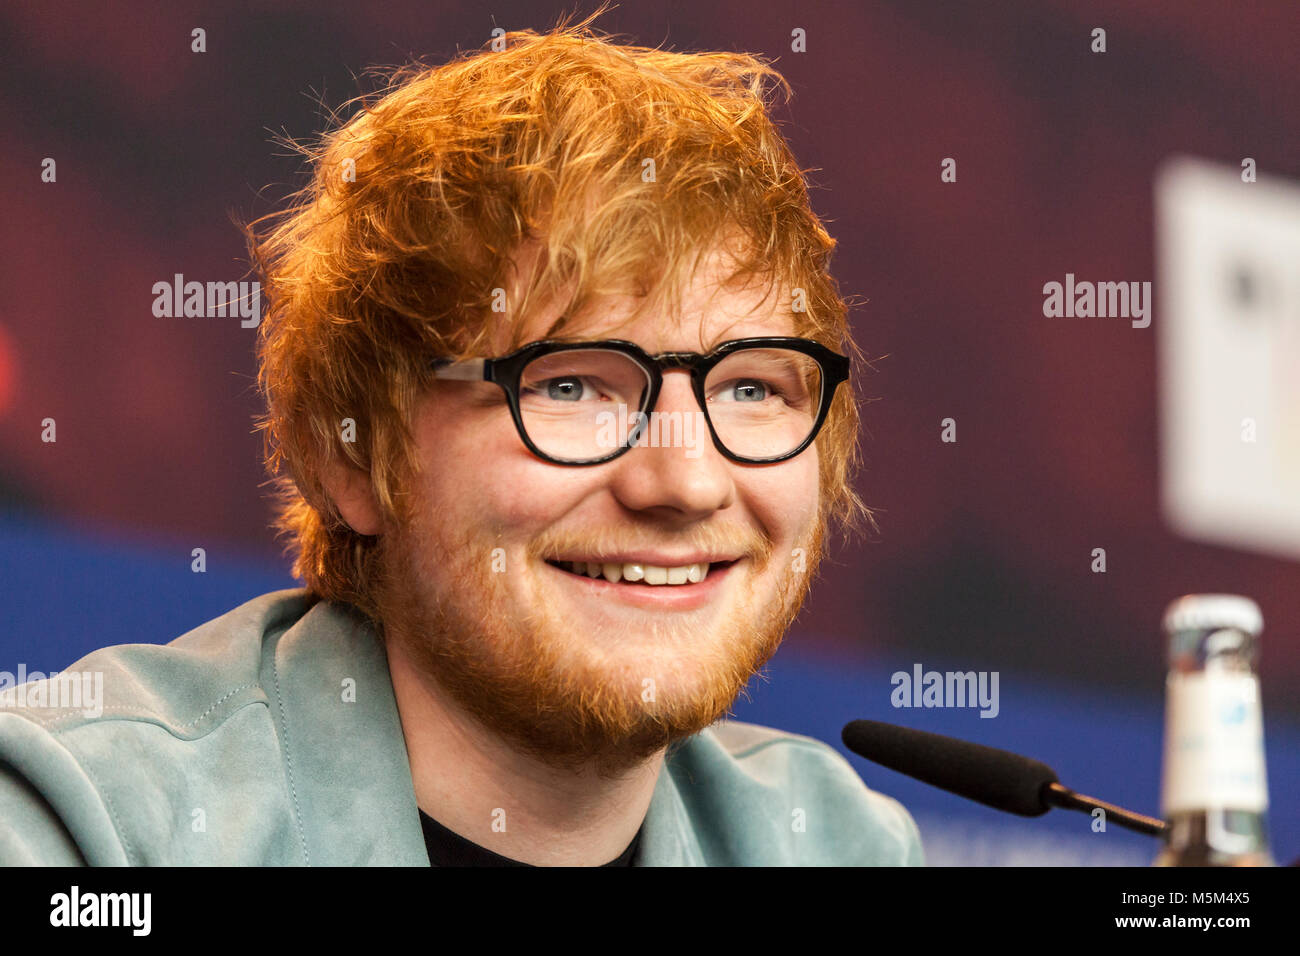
[611,369,736,519]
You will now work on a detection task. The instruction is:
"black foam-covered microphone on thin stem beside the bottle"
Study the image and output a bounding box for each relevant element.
[841,721,1167,836]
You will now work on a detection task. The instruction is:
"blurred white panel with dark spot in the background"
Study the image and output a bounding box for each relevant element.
[1153,157,1300,558]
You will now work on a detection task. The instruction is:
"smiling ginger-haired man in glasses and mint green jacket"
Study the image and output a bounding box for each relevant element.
[0,13,922,865]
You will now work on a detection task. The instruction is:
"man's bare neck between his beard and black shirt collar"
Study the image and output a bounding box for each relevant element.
[386,640,663,866]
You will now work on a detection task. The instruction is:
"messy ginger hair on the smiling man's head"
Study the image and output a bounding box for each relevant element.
[246,5,871,617]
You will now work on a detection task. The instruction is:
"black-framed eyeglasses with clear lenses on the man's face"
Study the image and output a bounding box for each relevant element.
[433,336,849,466]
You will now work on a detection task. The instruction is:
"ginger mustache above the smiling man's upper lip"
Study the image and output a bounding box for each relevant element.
[527,524,774,566]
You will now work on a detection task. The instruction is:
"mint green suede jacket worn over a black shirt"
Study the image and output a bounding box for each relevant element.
[0,591,922,866]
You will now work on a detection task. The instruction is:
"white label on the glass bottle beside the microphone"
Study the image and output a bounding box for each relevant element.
[1161,672,1269,819]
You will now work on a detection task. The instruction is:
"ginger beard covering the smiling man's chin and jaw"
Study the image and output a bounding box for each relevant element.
[371,530,802,775]
